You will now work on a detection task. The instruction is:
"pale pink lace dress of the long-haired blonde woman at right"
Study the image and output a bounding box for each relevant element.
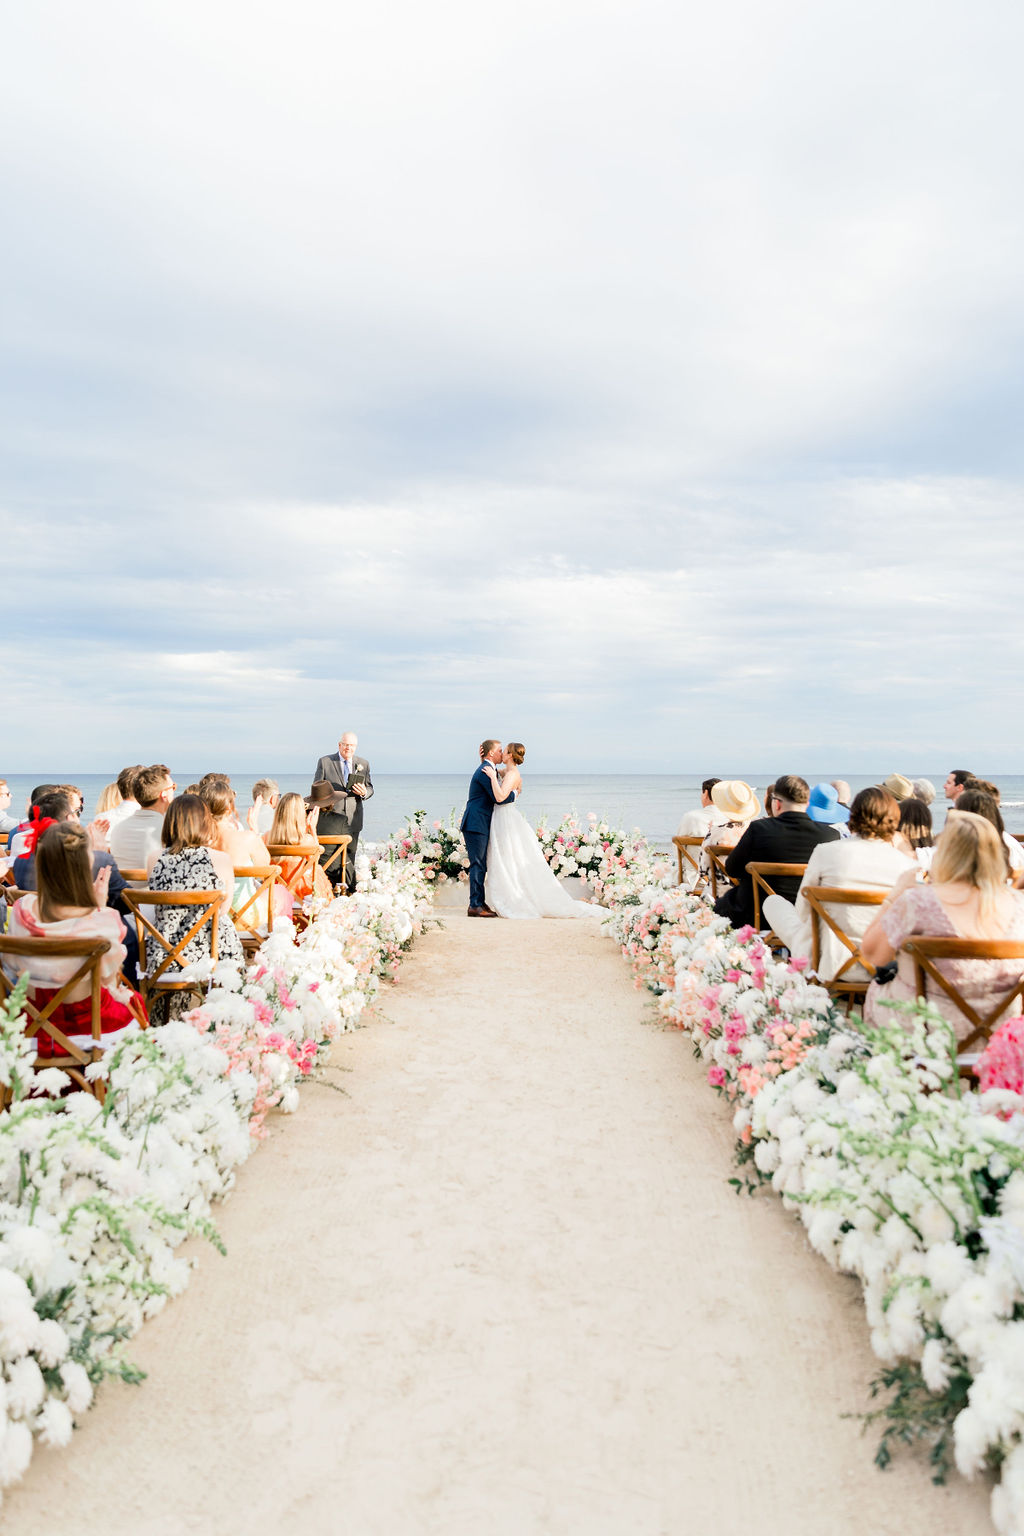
[864,885,1024,1040]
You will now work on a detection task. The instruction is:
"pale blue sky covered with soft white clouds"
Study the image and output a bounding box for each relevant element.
[0,0,1024,777]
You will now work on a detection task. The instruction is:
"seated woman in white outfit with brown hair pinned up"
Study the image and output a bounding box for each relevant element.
[763,786,927,982]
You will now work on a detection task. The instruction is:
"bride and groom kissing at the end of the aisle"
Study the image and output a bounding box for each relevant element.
[461,737,605,919]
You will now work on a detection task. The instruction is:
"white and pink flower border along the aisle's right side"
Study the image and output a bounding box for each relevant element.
[609,888,1024,1536]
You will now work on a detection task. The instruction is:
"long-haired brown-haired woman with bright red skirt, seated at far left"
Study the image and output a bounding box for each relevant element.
[6,820,146,1057]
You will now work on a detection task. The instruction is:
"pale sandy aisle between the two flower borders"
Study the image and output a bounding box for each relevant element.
[3,917,992,1536]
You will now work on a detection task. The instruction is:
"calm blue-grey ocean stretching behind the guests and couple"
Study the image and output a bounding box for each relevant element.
[6,766,1024,849]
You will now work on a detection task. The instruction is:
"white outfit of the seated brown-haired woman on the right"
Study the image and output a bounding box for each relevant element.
[763,837,918,982]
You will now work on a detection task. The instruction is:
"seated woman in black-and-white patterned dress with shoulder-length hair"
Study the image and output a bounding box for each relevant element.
[147,794,244,1018]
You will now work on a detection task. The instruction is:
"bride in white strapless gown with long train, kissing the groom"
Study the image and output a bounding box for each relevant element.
[484,742,606,919]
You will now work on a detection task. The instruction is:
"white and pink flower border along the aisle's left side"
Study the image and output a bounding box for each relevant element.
[0,865,430,1490]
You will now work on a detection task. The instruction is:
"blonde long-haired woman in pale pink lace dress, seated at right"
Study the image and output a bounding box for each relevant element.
[861,811,1024,1040]
